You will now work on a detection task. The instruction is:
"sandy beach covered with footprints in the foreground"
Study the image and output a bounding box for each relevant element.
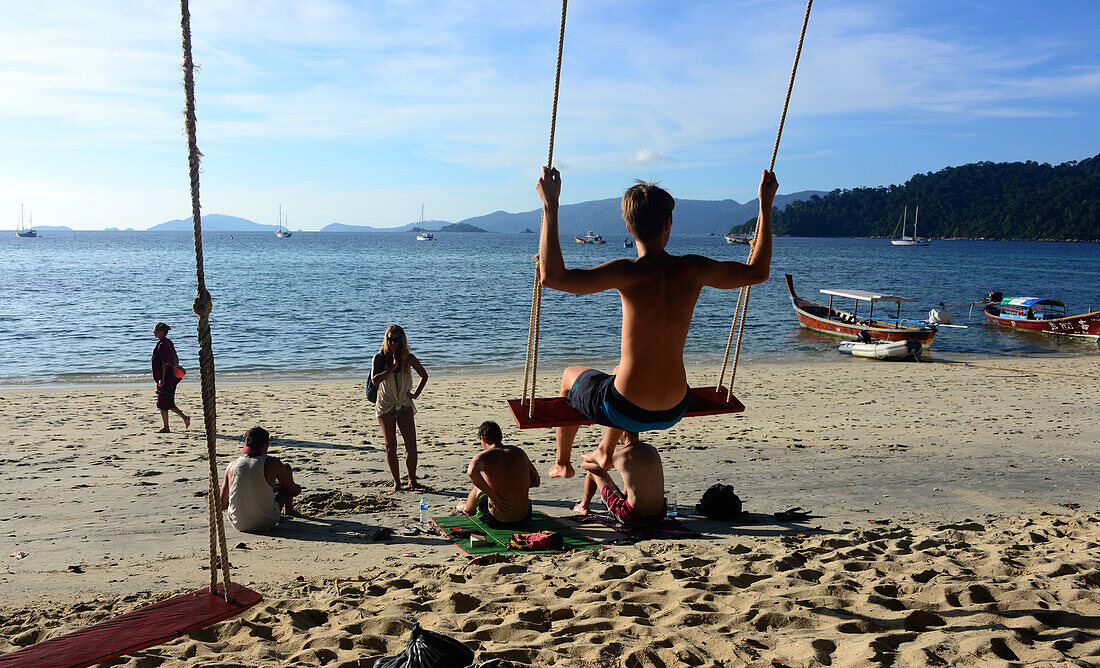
[0,355,1100,668]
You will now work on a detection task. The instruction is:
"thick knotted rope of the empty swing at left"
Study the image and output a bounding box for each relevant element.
[179,0,233,603]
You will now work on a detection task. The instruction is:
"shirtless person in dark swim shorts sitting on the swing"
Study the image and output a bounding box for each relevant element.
[538,167,779,478]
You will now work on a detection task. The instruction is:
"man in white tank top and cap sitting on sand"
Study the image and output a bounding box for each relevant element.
[221,427,301,533]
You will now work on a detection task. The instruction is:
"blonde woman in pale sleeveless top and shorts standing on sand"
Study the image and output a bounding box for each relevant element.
[371,325,428,492]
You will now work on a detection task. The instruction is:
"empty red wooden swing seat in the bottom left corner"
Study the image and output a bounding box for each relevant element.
[0,583,263,668]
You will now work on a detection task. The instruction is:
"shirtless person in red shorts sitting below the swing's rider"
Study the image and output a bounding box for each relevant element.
[573,431,667,526]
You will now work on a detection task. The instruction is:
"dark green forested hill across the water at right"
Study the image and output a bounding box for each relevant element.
[732,155,1100,241]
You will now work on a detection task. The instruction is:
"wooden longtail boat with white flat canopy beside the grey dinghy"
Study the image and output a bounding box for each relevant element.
[784,274,937,346]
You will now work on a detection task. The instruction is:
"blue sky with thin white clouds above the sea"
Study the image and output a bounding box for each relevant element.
[0,0,1100,230]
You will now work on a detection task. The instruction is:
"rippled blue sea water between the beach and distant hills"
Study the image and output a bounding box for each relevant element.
[0,231,1100,384]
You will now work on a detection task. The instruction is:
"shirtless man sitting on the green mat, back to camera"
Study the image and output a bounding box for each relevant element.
[455,421,541,528]
